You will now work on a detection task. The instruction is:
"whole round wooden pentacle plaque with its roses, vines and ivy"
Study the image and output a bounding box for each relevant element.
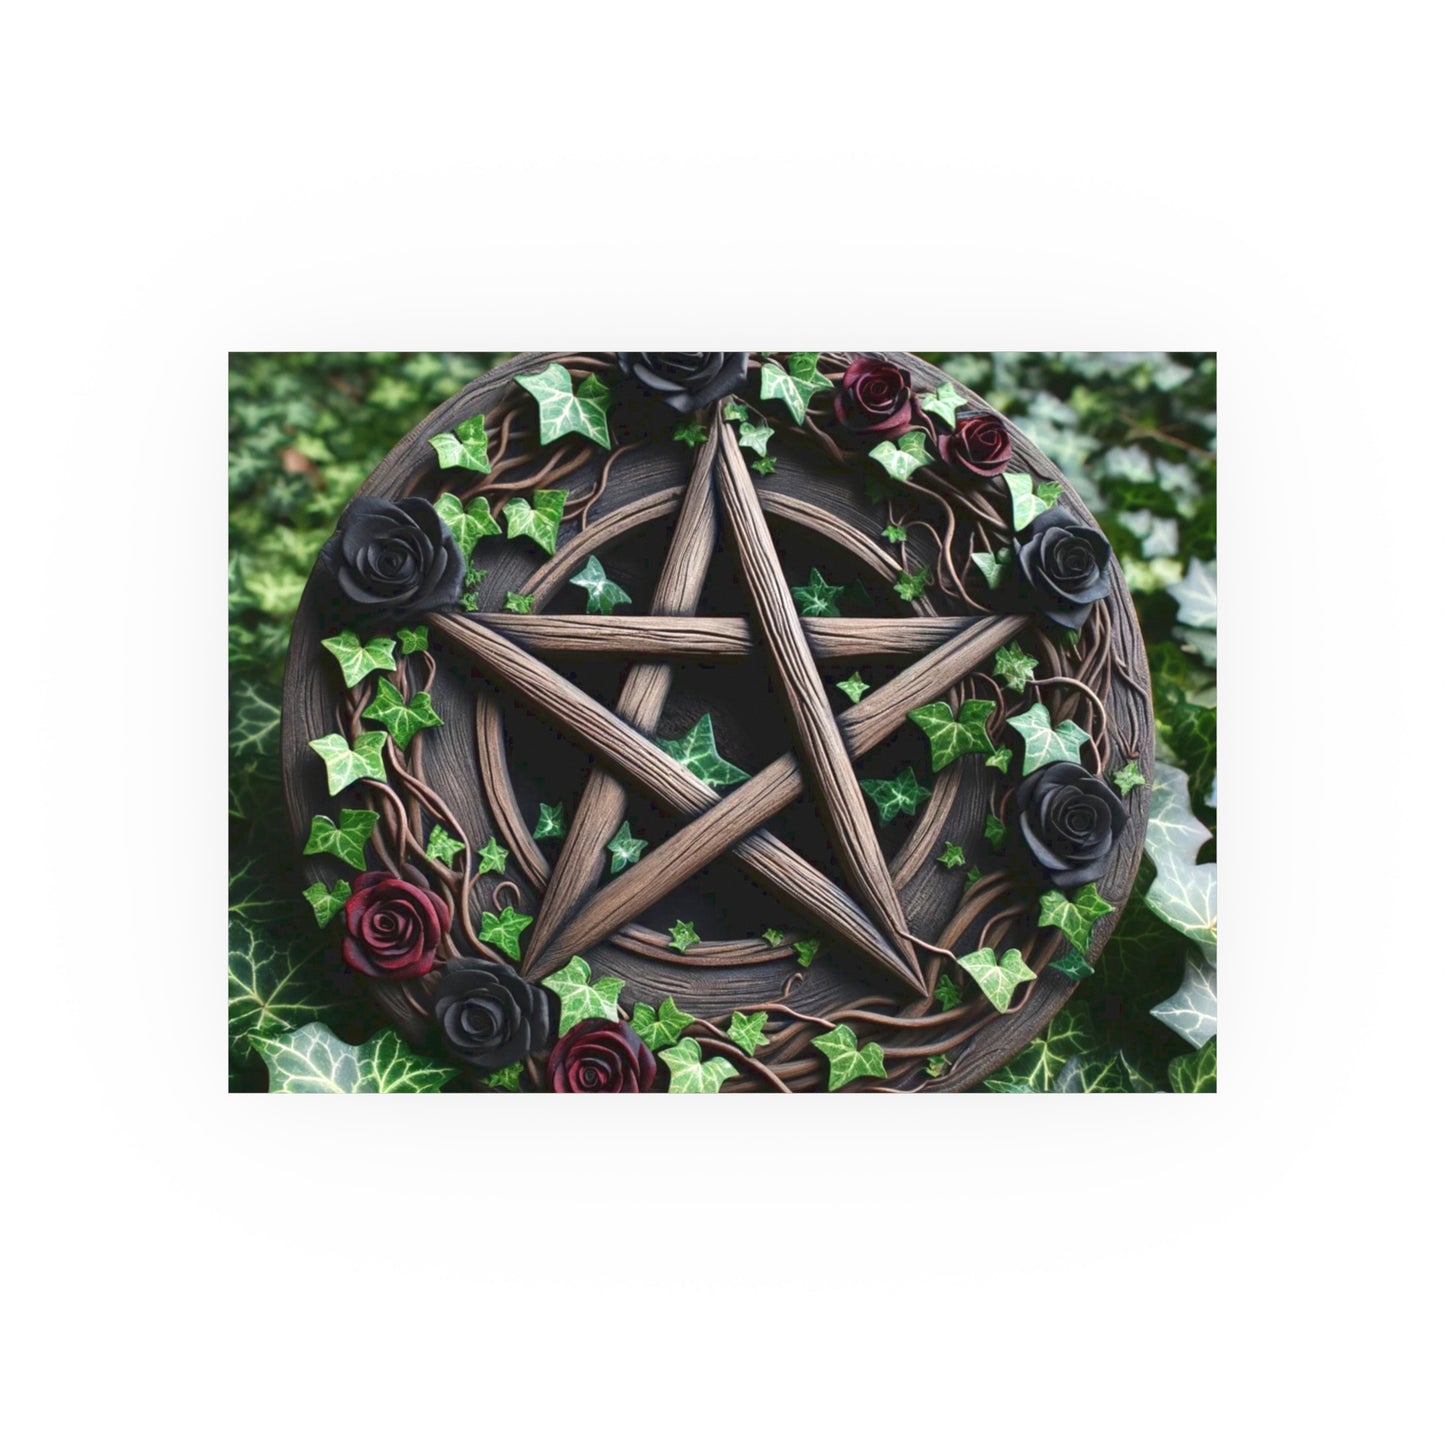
[282,353,1153,1092]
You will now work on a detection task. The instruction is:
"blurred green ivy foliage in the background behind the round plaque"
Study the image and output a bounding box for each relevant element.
[228,351,1217,1090]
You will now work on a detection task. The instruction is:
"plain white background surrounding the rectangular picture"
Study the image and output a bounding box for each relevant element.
[0,0,1442,1445]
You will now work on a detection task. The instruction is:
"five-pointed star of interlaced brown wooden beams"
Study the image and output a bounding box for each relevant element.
[428,403,1027,994]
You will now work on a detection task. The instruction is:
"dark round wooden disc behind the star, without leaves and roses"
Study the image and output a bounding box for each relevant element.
[282,353,1153,1090]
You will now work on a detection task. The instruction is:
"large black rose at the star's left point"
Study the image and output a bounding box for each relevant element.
[321,497,467,613]
